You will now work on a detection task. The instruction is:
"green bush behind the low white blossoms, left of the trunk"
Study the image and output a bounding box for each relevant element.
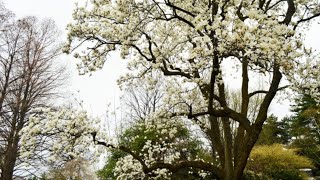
[97,122,208,179]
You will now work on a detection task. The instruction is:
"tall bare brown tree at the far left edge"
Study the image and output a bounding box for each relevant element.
[0,14,63,180]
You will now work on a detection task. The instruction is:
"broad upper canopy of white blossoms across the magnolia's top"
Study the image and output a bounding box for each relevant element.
[66,0,319,102]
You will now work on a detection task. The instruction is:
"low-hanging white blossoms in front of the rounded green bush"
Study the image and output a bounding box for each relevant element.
[114,111,200,179]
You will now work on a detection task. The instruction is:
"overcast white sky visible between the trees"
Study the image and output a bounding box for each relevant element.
[3,0,320,117]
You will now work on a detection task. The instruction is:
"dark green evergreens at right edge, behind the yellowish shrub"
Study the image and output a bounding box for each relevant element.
[256,95,320,174]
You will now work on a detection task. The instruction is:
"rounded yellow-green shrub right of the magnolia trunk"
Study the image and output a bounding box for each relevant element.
[246,144,313,179]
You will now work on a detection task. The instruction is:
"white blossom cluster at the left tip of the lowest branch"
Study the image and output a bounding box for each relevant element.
[20,108,102,165]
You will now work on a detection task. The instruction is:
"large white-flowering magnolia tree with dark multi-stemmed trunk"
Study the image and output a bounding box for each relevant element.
[65,0,320,179]
